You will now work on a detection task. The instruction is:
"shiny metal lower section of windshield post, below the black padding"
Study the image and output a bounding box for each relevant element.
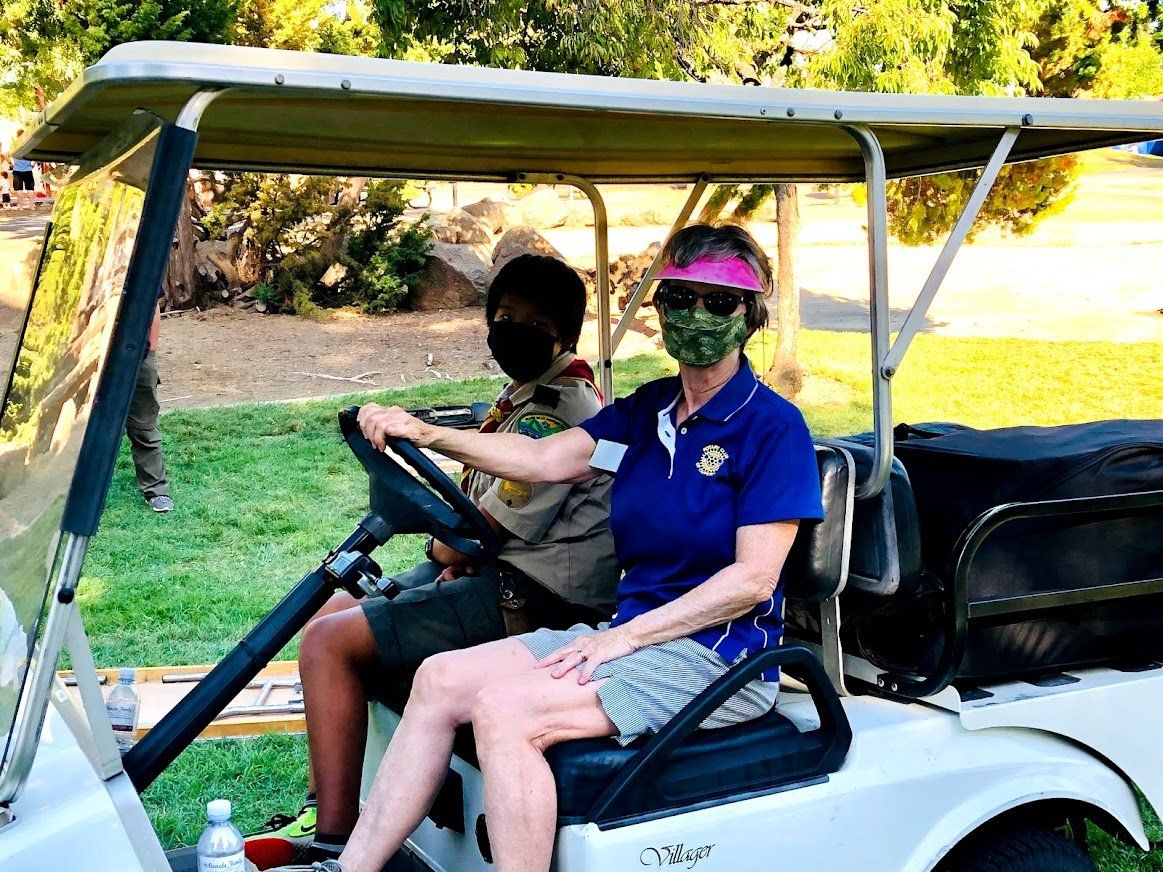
[0,533,88,805]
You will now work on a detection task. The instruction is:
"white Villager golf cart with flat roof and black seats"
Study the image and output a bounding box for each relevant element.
[0,43,1163,872]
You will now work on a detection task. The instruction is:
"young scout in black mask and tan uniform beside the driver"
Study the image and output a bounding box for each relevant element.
[247,255,618,869]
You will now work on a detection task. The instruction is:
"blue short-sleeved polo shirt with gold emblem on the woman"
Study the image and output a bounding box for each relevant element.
[582,358,823,680]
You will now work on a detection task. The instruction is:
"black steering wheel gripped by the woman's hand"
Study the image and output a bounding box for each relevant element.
[340,406,501,560]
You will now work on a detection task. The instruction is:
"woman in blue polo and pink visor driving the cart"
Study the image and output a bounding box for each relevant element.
[280,226,822,872]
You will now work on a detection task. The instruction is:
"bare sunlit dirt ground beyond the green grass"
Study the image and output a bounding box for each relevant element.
[0,152,1163,408]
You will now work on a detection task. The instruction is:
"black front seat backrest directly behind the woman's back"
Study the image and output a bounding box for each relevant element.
[785,445,856,602]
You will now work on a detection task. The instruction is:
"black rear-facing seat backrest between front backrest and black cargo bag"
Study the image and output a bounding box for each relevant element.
[826,439,921,596]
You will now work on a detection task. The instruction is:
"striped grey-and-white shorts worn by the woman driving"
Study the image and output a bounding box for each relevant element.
[513,623,779,745]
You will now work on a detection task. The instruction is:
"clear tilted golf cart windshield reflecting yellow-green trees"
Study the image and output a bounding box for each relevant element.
[0,115,159,771]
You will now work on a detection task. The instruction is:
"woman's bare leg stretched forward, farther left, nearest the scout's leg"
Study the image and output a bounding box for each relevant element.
[340,638,536,872]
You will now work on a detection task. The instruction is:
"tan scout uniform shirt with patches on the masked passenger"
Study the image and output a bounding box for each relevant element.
[465,352,619,615]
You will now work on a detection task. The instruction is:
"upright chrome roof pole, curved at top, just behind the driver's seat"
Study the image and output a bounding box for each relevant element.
[843,124,892,500]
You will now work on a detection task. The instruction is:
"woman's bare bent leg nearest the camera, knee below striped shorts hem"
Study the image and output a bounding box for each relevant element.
[472,669,618,872]
